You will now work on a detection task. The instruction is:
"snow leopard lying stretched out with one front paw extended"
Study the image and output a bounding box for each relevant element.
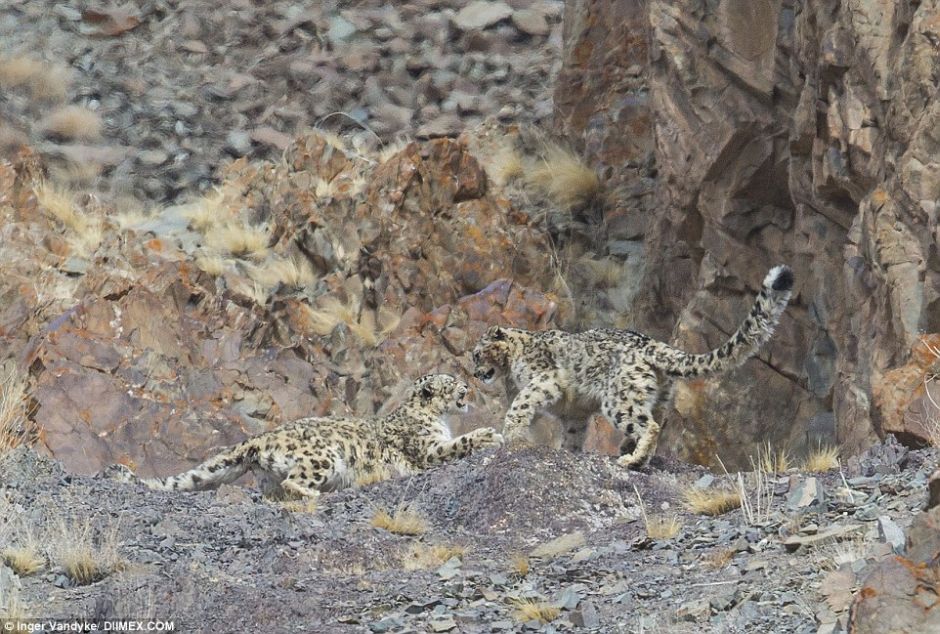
[112,374,503,498]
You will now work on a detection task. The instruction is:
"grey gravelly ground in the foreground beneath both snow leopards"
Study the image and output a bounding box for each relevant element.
[0,445,937,632]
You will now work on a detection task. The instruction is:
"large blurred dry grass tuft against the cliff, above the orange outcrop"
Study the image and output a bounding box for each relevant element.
[526,143,600,210]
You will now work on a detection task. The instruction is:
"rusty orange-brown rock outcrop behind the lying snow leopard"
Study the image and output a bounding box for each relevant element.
[0,134,556,473]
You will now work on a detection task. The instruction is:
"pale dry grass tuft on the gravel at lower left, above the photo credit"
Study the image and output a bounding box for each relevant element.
[49,518,124,585]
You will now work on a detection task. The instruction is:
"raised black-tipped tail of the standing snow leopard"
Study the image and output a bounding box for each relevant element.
[649,266,793,378]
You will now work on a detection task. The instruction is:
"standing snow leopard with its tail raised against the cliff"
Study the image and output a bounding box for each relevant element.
[473,266,793,467]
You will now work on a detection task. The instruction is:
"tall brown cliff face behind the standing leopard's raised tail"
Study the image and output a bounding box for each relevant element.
[556,0,940,462]
